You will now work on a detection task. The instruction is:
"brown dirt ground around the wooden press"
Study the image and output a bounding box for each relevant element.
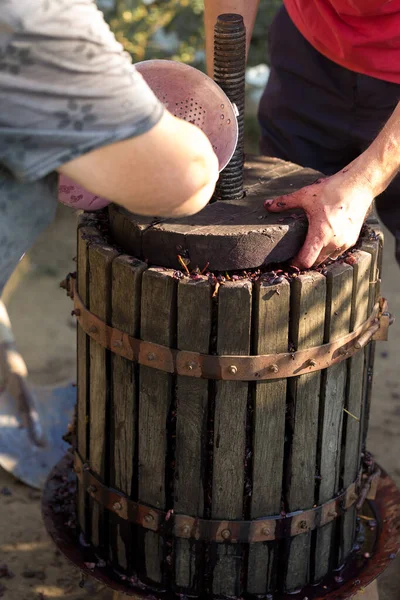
[0,207,400,600]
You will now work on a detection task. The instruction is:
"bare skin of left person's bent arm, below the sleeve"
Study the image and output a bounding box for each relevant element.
[58,112,218,217]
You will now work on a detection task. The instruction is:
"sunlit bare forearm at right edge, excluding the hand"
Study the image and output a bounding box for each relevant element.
[355,102,400,196]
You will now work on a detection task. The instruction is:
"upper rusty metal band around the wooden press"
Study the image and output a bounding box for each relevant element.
[62,276,393,381]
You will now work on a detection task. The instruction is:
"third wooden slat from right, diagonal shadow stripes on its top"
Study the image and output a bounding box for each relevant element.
[314,264,353,581]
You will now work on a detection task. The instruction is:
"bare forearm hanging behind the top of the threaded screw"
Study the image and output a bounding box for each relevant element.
[204,0,260,77]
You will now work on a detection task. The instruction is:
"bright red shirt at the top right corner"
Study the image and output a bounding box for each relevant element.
[284,0,400,84]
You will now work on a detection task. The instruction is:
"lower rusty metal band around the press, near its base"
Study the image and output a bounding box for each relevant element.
[74,451,380,544]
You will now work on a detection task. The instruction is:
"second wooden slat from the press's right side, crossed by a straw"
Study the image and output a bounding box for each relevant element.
[338,251,371,566]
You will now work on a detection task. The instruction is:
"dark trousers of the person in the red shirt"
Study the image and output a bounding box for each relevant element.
[259,7,400,263]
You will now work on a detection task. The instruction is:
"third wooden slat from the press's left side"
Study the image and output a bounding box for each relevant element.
[110,256,147,569]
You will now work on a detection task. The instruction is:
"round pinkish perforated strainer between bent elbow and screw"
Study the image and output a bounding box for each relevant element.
[135,60,238,171]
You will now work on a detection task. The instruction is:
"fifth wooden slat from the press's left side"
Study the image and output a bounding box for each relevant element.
[174,277,212,595]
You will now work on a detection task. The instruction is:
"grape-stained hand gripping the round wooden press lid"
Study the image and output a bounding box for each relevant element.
[265,169,374,269]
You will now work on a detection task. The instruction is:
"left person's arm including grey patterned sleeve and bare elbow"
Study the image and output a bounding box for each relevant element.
[0,0,218,216]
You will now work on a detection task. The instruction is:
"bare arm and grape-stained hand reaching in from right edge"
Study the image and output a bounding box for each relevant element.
[265,103,400,268]
